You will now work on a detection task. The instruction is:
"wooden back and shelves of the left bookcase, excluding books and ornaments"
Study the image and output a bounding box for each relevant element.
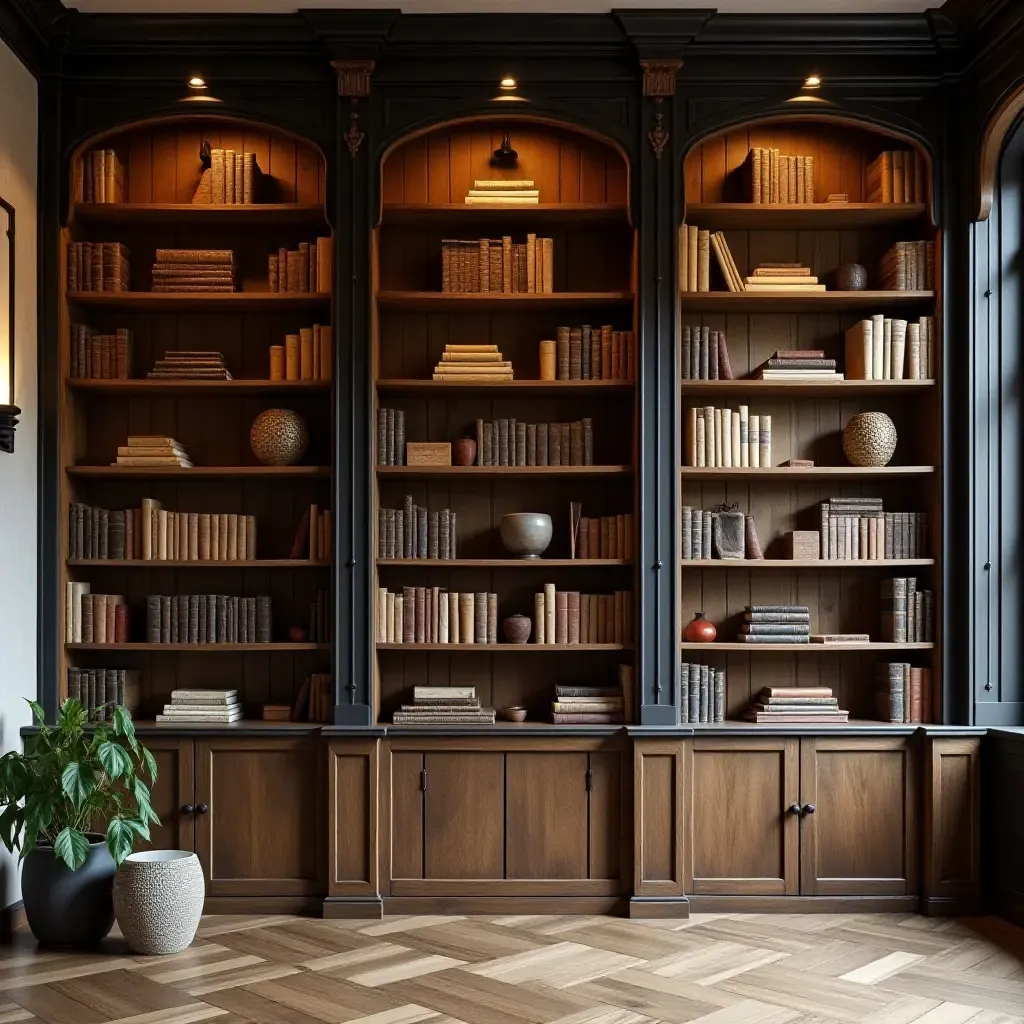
[57,117,335,720]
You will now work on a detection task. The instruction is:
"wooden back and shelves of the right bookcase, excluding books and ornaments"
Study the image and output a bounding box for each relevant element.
[677,118,943,723]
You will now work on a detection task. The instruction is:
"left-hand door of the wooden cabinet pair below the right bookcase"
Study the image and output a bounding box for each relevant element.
[688,738,799,896]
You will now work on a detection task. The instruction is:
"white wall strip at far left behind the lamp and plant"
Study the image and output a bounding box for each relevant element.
[0,41,39,907]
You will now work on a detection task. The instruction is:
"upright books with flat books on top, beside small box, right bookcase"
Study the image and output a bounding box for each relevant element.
[820,498,930,561]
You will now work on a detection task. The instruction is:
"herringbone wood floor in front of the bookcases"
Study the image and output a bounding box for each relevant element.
[0,914,1024,1024]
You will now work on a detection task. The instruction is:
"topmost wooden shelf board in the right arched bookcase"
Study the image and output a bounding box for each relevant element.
[686,203,927,231]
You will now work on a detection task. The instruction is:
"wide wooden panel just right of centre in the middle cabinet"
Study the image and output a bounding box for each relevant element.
[506,753,588,879]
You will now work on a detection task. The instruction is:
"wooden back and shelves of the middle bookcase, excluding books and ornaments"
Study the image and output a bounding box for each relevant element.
[369,117,637,728]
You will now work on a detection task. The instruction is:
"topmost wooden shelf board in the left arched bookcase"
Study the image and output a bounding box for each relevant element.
[72,203,327,227]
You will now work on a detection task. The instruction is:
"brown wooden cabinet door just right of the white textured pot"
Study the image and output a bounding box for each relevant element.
[196,738,326,896]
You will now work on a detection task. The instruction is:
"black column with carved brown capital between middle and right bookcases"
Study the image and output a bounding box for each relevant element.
[637,59,682,726]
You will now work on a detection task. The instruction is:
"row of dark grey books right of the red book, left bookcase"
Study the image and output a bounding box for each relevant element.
[145,594,271,644]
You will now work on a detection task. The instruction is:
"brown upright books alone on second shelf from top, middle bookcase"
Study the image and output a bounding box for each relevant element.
[441,233,555,294]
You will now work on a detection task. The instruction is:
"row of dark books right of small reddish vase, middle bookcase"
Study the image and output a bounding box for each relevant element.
[476,416,594,466]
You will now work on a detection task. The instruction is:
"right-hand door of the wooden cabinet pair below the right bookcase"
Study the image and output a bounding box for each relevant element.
[800,736,918,896]
